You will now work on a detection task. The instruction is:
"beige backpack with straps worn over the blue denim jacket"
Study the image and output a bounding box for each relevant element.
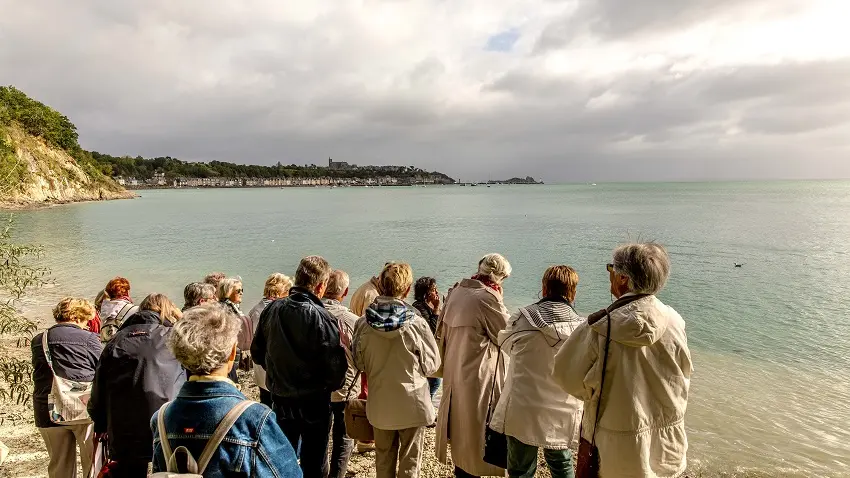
[150,400,255,478]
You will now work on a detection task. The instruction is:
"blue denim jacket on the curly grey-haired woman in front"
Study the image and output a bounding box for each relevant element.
[151,381,302,478]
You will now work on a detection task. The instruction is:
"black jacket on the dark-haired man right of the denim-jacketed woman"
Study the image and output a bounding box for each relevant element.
[251,287,348,400]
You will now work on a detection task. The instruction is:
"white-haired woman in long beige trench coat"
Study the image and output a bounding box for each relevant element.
[437,254,511,478]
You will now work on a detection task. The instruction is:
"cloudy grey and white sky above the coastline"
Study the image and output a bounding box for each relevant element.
[0,0,850,182]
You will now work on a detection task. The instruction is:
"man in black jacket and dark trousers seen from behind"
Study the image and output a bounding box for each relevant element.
[251,256,348,478]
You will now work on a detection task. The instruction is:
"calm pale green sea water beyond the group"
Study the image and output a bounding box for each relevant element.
[11,182,850,476]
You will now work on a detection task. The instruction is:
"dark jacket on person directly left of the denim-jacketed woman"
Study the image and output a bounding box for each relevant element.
[88,310,186,461]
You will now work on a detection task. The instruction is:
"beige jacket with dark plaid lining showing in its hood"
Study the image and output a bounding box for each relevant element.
[352,297,440,430]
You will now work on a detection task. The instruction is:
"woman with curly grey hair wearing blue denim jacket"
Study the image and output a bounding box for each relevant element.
[150,303,301,478]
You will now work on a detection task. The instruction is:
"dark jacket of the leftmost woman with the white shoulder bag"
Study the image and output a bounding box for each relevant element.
[30,323,103,428]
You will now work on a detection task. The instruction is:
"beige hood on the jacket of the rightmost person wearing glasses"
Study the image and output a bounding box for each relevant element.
[589,295,676,347]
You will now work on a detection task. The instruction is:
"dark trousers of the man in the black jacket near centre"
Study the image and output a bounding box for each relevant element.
[273,394,331,478]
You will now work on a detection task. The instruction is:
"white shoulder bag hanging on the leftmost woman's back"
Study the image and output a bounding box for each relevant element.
[41,329,92,425]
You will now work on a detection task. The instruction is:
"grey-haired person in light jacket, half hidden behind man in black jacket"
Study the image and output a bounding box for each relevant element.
[322,269,360,478]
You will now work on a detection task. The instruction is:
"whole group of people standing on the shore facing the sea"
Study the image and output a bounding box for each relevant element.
[32,243,692,478]
